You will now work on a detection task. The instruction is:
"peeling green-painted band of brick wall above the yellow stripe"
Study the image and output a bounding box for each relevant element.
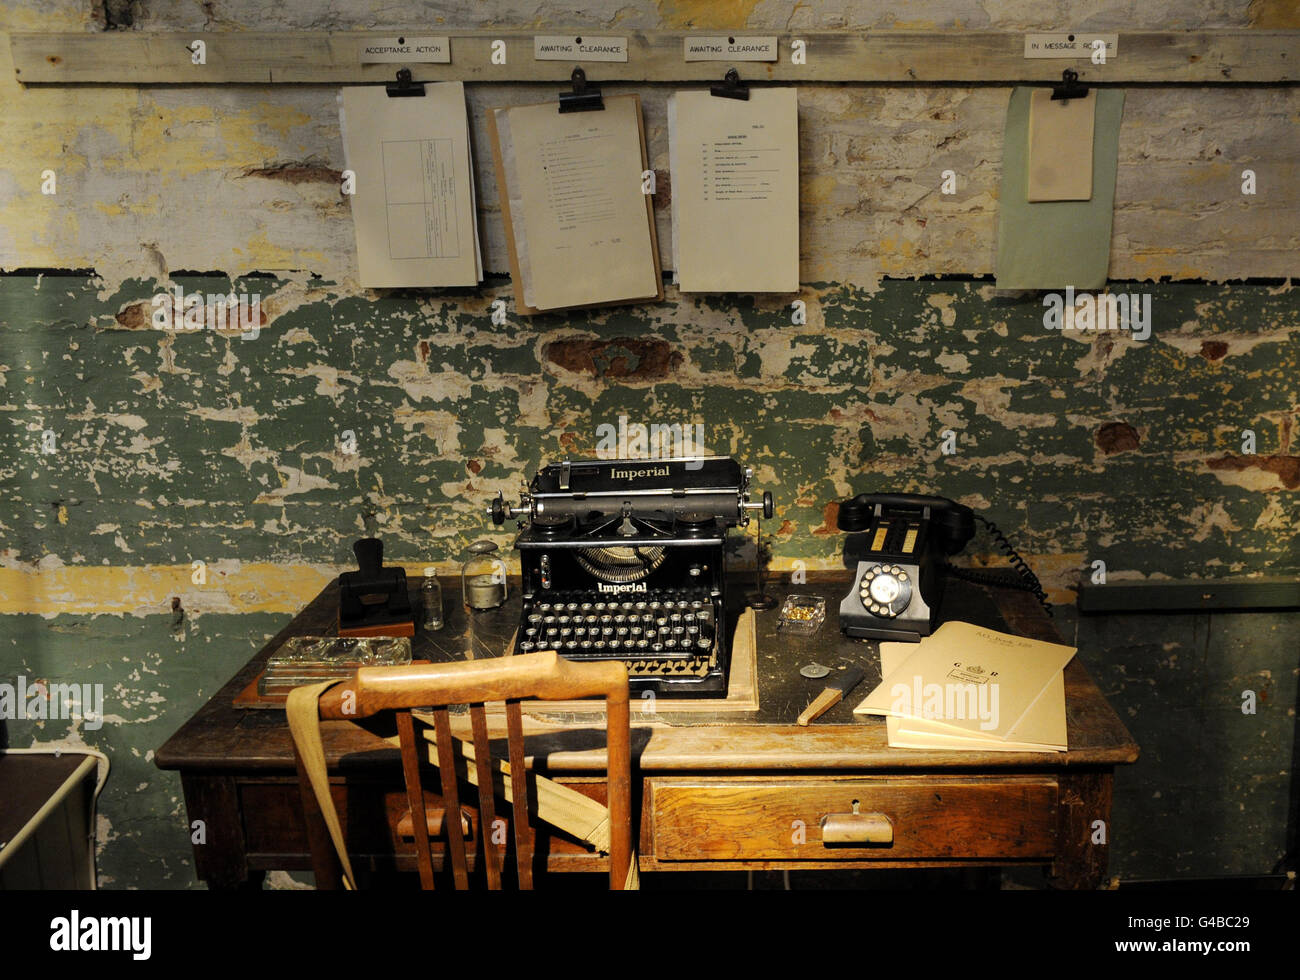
[0,277,1300,577]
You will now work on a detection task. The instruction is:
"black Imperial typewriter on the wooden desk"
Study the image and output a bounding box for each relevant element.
[490,456,772,697]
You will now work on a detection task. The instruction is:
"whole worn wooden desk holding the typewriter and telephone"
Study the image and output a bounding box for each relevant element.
[156,573,1138,888]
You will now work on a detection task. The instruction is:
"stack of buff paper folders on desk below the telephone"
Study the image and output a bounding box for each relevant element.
[854,623,1075,751]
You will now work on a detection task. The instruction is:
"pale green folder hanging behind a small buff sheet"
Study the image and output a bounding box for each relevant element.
[997,86,1125,290]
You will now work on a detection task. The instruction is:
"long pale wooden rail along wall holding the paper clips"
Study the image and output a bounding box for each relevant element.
[9,27,1300,86]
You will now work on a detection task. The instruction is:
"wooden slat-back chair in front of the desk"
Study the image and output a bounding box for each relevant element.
[289,652,636,889]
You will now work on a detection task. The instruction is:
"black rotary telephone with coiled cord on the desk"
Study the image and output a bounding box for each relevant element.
[836,494,1050,641]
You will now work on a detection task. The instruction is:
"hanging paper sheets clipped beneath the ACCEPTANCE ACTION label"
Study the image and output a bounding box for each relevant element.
[339,82,484,287]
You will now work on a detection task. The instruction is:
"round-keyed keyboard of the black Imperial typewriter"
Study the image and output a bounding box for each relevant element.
[519,593,718,676]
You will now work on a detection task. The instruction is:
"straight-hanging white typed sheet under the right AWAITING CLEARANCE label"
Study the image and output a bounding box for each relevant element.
[668,88,800,292]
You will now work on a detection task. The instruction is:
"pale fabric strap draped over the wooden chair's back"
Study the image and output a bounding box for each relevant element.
[285,680,641,890]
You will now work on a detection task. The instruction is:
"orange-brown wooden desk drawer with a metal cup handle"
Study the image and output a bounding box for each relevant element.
[646,776,1057,862]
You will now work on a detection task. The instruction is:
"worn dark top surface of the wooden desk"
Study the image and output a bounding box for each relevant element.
[156,572,1138,775]
